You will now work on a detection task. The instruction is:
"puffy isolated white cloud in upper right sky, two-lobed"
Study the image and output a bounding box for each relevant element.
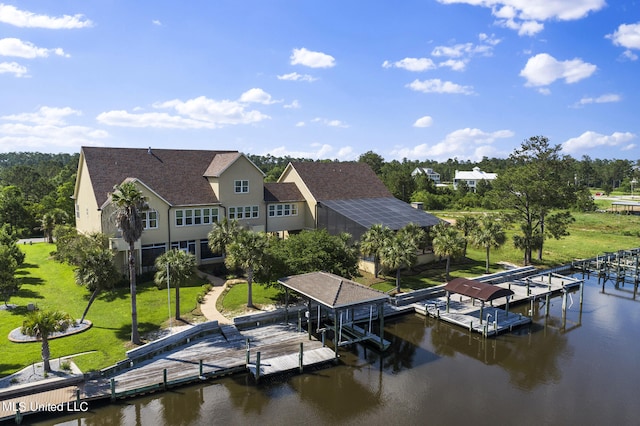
[520,53,597,87]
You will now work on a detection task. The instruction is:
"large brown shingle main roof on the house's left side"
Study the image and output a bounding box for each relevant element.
[82,147,237,206]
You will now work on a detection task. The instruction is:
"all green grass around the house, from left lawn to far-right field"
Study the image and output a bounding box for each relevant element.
[5,212,640,377]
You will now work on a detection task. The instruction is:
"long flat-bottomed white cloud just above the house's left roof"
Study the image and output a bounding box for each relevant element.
[97,92,271,129]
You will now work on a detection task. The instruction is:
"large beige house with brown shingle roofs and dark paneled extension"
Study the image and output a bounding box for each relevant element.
[74,147,439,271]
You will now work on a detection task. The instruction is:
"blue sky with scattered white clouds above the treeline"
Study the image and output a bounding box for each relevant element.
[0,0,640,161]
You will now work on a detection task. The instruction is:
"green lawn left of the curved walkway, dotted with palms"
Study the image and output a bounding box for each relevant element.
[0,243,204,377]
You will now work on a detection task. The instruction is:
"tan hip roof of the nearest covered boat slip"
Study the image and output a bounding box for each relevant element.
[278,272,389,309]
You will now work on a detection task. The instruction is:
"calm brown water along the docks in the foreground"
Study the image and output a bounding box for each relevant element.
[33,279,640,426]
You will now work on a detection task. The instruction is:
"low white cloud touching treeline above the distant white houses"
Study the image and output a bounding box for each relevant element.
[391,128,514,161]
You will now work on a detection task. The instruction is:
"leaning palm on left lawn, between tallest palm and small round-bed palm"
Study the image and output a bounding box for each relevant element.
[74,248,120,324]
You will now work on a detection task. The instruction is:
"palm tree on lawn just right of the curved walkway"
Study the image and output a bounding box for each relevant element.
[224,229,268,308]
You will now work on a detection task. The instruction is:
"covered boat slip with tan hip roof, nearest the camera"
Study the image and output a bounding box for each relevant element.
[278,272,390,356]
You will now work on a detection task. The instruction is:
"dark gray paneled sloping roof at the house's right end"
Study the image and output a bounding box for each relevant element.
[321,197,440,231]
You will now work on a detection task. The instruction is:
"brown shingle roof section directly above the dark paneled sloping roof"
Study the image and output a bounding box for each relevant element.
[291,162,393,201]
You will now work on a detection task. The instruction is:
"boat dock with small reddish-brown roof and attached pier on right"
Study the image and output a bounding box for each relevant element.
[415,273,582,336]
